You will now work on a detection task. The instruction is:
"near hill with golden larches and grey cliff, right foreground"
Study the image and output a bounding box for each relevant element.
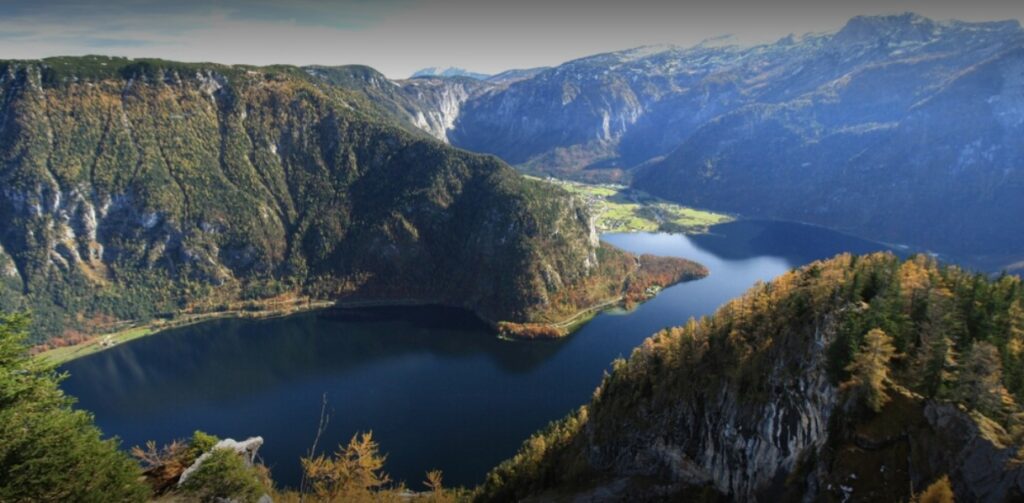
[478,254,1024,502]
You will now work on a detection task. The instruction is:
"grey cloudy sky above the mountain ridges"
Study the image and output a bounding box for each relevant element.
[6,0,1024,78]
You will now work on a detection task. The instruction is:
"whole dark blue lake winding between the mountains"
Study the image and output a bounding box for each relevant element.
[62,221,884,489]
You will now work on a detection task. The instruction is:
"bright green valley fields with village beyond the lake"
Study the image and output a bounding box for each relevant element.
[538,178,732,234]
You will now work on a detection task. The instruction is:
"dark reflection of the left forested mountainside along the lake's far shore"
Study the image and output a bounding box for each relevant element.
[63,306,565,407]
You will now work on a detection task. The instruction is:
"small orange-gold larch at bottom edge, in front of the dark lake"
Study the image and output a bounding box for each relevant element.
[302,432,391,501]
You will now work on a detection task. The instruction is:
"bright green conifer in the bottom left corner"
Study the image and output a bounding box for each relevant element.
[0,315,150,502]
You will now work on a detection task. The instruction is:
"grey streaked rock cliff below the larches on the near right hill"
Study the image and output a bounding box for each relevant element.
[587,322,838,500]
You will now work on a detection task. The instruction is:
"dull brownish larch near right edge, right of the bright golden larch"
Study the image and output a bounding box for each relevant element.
[955,341,1017,421]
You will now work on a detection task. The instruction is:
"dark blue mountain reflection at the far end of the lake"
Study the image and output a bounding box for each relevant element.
[689,220,890,263]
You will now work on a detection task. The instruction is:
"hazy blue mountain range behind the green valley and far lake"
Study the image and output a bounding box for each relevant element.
[327,13,1024,269]
